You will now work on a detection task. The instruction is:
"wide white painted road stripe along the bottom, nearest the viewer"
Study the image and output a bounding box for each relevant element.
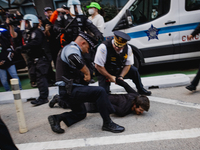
[17,128,200,150]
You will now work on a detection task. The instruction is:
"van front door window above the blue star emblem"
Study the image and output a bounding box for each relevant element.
[129,0,170,25]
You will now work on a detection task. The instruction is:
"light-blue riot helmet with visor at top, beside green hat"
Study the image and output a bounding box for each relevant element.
[67,0,83,15]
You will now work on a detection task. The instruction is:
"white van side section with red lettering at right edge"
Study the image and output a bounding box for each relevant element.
[179,0,200,59]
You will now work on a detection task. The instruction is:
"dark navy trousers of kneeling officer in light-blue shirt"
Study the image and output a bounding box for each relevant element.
[57,86,115,127]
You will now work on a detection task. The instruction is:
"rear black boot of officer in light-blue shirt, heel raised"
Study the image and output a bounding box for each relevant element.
[48,115,65,133]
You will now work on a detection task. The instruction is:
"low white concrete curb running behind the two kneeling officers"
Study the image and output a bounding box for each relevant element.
[0,74,190,104]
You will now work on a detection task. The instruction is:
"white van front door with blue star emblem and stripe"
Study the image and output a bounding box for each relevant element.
[114,0,179,64]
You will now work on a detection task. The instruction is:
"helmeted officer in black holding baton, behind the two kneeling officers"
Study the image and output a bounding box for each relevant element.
[54,0,103,46]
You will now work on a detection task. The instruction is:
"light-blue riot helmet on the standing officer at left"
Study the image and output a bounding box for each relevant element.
[21,14,39,30]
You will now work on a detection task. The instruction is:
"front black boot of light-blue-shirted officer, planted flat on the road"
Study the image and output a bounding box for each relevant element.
[102,120,125,133]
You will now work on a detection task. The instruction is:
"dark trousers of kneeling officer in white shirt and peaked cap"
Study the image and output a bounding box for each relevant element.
[97,66,144,93]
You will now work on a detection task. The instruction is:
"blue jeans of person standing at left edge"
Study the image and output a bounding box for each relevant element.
[0,65,22,91]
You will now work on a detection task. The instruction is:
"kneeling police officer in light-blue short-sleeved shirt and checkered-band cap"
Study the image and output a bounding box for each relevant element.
[48,31,125,133]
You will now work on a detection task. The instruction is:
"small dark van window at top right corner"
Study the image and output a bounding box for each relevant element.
[185,0,200,11]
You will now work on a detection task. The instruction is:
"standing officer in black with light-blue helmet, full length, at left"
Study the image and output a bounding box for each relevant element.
[15,14,50,106]
